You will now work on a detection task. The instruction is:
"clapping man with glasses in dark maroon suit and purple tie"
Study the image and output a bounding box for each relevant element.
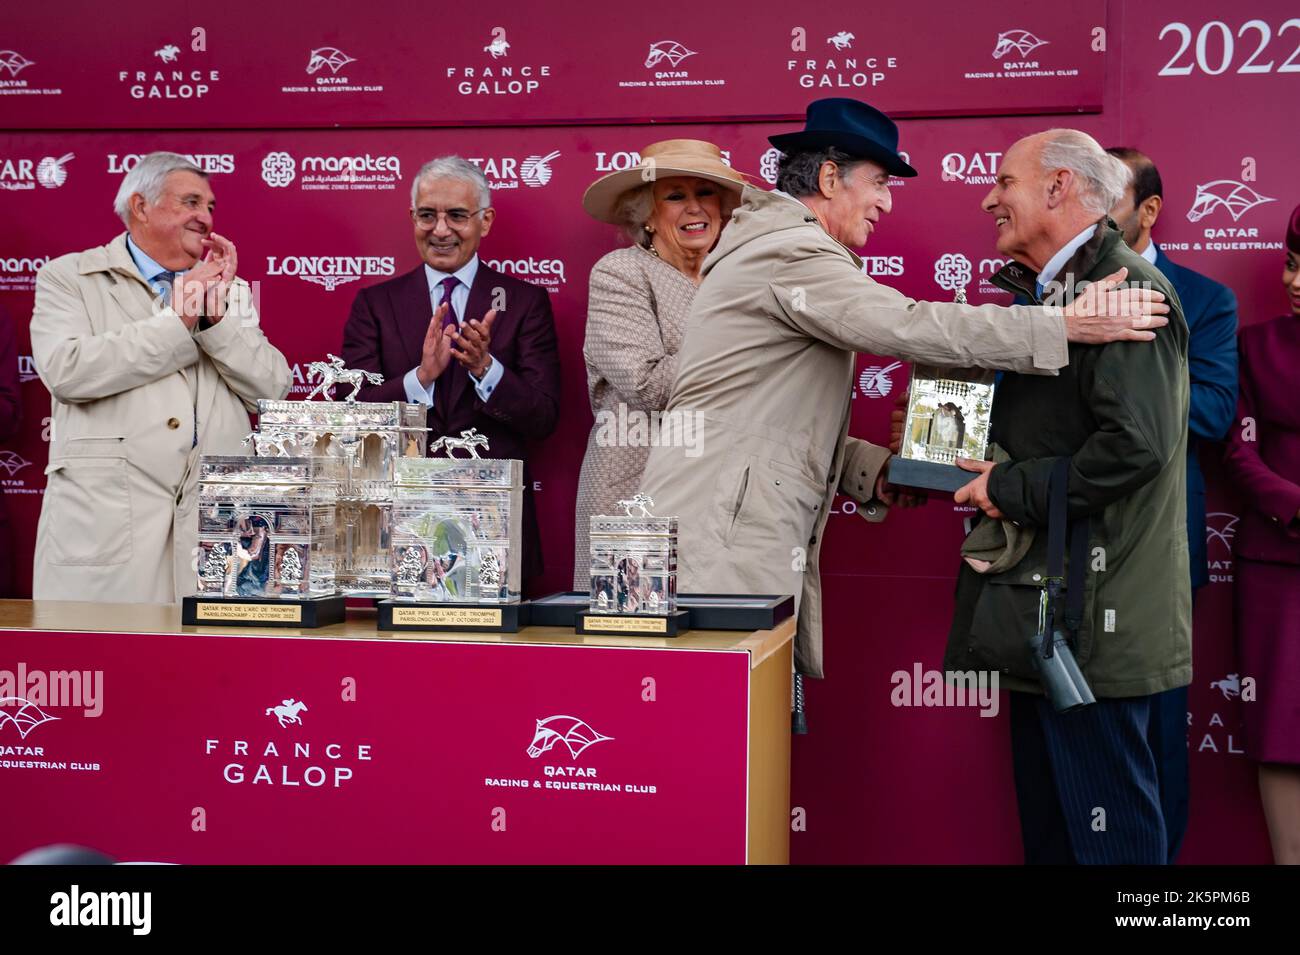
[343,156,560,585]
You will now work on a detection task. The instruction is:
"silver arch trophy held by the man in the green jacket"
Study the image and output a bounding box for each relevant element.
[889,256,995,491]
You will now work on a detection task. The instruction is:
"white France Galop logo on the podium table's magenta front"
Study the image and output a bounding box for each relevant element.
[203,698,374,790]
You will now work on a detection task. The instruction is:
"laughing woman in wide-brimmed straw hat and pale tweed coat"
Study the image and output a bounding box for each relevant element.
[573,139,745,590]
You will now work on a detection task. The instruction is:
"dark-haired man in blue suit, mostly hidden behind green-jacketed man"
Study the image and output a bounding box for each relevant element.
[1106,147,1236,863]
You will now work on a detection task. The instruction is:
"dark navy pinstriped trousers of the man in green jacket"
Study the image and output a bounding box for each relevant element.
[1010,693,1166,865]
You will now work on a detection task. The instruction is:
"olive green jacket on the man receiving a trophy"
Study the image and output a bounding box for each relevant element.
[944,220,1192,696]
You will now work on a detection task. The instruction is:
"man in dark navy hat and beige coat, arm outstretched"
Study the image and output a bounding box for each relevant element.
[642,99,1167,677]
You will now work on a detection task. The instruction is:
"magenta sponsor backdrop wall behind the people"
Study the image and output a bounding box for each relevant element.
[0,0,1300,863]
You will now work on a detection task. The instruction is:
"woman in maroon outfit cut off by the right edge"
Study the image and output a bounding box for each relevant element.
[1226,205,1300,865]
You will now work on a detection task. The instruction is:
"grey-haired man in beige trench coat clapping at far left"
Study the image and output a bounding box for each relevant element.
[31,152,290,603]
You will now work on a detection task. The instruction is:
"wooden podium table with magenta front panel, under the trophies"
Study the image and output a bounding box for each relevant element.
[0,600,794,864]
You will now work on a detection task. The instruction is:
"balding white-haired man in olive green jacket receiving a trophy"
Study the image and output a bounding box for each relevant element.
[944,130,1192,865]
